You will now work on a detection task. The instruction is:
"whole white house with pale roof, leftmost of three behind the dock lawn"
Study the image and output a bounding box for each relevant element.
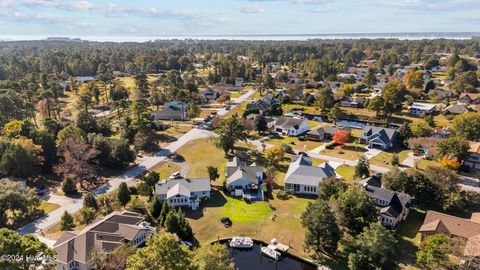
[155,175,211,210]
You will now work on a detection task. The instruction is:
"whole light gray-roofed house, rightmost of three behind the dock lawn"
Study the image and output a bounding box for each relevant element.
[283,155,336,195]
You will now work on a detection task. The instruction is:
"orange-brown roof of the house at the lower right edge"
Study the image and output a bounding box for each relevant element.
[420,210,480,238]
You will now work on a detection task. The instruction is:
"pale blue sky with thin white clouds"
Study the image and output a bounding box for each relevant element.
[0,0,480,37]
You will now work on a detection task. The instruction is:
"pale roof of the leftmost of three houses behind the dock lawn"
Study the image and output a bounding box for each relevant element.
[155,177,211,198]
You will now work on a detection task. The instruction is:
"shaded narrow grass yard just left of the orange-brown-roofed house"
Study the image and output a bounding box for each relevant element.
[397,207,425,269]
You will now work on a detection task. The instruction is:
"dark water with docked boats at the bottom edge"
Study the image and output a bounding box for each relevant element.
[222,241,317,270]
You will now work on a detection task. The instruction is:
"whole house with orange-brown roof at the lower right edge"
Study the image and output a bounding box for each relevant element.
[419,210,480,241]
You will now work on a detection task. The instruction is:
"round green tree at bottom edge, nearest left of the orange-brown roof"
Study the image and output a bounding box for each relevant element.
[348,222,398,270]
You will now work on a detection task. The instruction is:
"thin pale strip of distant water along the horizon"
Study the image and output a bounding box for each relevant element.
[0,32,480,42]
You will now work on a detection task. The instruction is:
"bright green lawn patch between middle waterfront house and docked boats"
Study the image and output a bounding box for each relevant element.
[221,199,272,223]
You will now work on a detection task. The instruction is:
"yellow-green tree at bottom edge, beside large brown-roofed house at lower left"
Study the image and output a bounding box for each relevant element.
[126,233,193,270]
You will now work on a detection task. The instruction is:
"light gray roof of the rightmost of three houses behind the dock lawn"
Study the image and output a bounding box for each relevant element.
[284,155,336,186]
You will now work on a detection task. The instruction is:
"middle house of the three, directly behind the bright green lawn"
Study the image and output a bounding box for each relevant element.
[225,156,264,199]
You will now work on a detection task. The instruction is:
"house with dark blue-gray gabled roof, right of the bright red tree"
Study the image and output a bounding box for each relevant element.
[360,125,397,150]
